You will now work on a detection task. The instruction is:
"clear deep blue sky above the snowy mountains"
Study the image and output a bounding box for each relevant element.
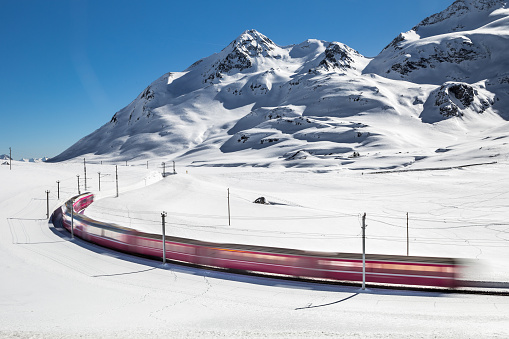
[0,0,453,159]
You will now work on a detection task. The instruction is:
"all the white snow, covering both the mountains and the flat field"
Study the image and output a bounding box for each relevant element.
[5,0,509,338]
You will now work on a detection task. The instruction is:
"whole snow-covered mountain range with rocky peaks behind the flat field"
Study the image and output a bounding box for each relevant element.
[51,0,509,168]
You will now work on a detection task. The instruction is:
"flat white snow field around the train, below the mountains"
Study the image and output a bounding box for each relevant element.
[0,157,509,338]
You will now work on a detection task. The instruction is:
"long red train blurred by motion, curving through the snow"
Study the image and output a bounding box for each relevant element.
[57,193,460,288]
